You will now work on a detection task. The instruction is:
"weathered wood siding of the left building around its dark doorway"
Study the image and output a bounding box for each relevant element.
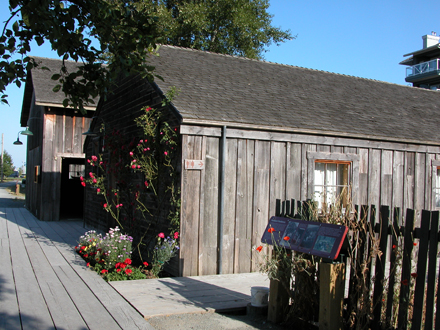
[26,94,92,221]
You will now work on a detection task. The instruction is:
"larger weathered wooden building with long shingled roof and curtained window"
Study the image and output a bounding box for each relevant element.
[81,46,440,276]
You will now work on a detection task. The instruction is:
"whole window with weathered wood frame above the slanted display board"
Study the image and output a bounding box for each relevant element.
[307,151,360,210]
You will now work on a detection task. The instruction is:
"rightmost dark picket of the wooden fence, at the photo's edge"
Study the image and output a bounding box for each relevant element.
[425,211,439,329]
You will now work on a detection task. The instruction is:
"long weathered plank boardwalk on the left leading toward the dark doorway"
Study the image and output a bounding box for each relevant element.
[0,206,154,330]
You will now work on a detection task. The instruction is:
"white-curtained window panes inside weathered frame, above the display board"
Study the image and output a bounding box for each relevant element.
[313,160,351,210]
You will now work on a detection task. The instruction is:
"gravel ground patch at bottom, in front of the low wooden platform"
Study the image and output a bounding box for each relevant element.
[148,312,291,330]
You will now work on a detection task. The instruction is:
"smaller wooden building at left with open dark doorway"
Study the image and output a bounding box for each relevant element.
[20,57,95,221]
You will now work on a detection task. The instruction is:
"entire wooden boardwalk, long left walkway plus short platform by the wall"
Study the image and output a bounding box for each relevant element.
[0,205,269,330]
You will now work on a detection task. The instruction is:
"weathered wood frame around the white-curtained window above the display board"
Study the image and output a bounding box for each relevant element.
[307,151,360,210]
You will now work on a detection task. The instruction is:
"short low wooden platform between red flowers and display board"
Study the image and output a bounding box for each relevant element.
[111,273,269,319]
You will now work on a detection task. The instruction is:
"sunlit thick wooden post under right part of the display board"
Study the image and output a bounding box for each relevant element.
[319,263,345,330]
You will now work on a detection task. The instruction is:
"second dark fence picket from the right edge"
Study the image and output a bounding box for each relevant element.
[411,210,431,330]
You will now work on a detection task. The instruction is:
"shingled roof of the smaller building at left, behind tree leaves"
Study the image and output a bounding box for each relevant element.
[21,56,98,126]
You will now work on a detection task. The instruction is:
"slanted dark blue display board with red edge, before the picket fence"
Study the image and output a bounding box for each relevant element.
[261,217,348,260]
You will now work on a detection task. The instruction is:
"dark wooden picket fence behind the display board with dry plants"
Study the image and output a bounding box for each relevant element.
[276,200,440,330]
